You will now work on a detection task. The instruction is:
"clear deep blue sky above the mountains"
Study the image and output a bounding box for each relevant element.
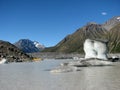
[0,0,120,47]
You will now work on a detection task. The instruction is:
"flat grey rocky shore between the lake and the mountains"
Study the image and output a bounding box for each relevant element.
[28,52,120,60]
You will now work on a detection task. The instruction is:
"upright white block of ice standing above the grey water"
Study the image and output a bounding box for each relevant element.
[84,39,108,60]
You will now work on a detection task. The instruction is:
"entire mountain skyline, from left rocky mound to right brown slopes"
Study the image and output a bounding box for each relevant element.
[0,16,120,59]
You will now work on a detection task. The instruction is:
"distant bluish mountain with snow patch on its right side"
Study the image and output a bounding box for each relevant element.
[14,39,45,53]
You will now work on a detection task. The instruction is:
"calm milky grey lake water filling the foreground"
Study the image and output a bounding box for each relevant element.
[0,60,120,90]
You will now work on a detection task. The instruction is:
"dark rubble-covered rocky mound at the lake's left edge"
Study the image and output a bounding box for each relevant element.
[0,40,31,62]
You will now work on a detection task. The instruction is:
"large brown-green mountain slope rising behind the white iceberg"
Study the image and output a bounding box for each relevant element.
[43,16,120,53]
